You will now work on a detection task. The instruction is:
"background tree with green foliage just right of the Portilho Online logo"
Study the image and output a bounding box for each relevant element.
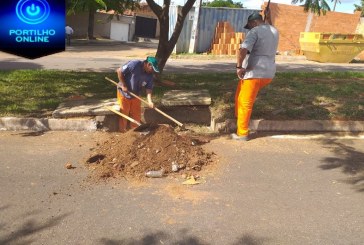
[66,0,139,39]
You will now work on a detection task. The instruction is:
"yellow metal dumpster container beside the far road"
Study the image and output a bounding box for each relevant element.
[300,32,364,63]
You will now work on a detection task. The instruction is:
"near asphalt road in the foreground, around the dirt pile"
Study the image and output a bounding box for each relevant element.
[0,132,364,245]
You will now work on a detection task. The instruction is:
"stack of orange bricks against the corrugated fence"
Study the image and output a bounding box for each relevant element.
[211,22,245,55]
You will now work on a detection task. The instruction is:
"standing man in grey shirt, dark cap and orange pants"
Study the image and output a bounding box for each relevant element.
[231,10,279,141]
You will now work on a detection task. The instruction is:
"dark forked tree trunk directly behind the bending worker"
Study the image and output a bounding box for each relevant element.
[146,0,196,72]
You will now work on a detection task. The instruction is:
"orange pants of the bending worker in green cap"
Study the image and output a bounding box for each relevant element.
[117,90,142,132]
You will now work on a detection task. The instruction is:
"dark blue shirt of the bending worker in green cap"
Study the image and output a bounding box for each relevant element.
[118,60,153,99]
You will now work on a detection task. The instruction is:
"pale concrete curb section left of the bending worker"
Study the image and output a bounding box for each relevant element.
[0,117,97,131]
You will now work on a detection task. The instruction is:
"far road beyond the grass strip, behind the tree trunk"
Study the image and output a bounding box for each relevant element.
[0,42,364,73]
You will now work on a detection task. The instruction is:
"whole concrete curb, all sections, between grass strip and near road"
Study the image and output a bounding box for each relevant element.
[0,117,364,133]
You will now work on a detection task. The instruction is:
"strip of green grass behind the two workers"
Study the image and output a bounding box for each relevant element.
[0,70,364,120]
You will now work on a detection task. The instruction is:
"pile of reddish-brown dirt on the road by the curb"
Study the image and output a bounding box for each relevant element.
[87,125,216,179]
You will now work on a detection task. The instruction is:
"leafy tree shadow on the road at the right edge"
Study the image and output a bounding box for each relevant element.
[320,140,364,192]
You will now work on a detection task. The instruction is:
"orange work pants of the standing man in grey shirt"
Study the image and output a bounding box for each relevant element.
[235,78,272,136]
